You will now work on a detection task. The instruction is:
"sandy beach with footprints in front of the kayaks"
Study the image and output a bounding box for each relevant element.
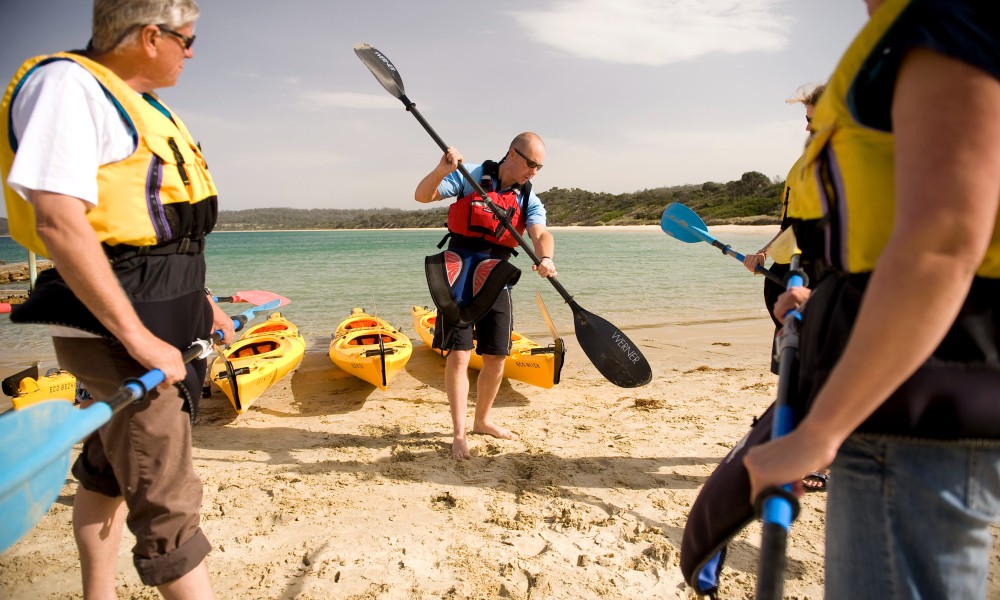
[0,318,836,600]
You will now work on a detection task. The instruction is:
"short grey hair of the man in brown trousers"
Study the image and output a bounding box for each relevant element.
[90,0,200,54]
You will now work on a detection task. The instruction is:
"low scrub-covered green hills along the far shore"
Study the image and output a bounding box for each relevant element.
[0,171,784,235]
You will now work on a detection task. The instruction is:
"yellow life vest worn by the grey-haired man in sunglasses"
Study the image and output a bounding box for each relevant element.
[0,52,217,256]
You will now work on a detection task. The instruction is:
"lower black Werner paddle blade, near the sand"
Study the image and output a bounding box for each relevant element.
[569,302,653,387]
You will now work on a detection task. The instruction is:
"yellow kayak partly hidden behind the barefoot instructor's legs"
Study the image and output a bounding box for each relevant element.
[410,306,566,388]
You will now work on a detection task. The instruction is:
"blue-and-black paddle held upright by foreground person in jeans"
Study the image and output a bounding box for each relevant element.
[754,254,805,600]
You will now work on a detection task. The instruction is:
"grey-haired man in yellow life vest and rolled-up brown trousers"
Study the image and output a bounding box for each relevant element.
[0,0,233,598]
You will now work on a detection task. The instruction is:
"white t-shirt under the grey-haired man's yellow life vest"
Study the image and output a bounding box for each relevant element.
[7,60,135,205]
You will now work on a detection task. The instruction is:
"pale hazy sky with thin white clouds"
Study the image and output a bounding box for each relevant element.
[0,0,867,216]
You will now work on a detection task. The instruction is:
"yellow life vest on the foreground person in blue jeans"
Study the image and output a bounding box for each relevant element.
[788,0,1000,278]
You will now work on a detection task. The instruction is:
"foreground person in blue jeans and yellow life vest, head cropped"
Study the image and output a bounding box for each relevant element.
[744,0,1000,598]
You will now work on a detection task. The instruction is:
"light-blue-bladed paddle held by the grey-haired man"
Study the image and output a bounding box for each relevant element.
[0,300,279,552]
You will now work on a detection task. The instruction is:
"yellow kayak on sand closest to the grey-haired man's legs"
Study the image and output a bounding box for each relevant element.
[211,313,306,414]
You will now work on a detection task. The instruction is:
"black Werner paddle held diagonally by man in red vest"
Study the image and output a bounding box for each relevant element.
[354,44,653,388]
